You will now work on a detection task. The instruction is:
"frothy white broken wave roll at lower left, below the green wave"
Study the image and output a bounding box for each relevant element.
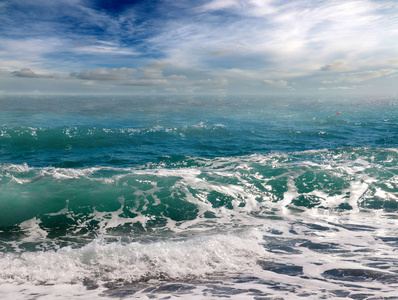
[0,230,266,284]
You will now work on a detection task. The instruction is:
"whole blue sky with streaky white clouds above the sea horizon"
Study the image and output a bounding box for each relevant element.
[0,0,398,95]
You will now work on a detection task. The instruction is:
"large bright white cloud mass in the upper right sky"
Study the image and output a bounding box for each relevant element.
[156,0,398,77]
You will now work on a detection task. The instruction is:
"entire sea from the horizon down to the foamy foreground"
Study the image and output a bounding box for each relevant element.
[0,96,398,299]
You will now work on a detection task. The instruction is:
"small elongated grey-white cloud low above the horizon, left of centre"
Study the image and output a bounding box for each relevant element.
[70,68,136,80]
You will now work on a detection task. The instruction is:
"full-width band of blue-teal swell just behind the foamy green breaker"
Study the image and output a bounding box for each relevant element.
[0,116,397,168]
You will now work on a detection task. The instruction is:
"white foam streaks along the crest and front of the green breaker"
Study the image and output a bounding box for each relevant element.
[0,149,398,233]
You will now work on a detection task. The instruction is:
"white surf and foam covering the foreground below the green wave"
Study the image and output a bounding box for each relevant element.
[0,211,398,300]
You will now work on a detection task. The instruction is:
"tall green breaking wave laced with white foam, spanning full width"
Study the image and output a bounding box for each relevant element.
[0,148,398,237]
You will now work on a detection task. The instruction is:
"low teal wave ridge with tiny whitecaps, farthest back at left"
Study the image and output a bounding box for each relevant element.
[0,122,232,150]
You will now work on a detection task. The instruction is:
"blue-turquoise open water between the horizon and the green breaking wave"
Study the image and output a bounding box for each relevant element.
[1,97,397,168]
